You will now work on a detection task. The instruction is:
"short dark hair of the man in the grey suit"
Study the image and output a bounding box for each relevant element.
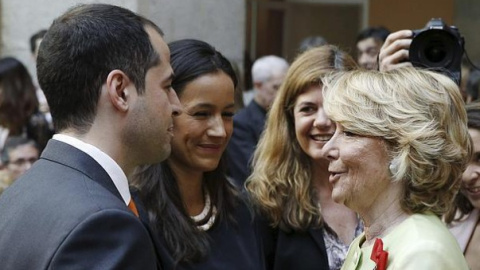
[37,4,163,133]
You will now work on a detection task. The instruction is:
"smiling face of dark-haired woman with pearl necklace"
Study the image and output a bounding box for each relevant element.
[168,71,234,172]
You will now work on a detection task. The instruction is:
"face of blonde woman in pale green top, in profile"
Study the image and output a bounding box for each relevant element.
[324,123,391,213]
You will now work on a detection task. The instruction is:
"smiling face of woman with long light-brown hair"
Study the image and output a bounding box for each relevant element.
[293,85,335,159]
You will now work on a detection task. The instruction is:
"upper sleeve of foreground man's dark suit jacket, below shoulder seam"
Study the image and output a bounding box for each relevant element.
[52,209,156,269]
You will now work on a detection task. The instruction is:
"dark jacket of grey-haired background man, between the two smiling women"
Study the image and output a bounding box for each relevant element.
[227,100,267,187]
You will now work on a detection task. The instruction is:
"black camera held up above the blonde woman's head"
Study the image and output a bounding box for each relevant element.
[409,19,465,85]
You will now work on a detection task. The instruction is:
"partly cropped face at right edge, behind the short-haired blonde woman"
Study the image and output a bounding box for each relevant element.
[461,128,480,209]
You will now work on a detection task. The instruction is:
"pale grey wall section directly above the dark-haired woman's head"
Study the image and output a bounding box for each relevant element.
[139,0,245,66]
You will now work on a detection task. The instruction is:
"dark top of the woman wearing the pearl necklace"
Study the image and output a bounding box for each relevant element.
[159,197,265,270]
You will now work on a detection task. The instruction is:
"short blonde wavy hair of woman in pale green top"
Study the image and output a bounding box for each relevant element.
[323,68,472,216]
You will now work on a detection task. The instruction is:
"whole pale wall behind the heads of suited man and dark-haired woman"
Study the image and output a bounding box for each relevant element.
[0,0,245,83]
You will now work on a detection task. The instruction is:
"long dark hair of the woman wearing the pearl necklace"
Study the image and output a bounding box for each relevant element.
[133,39,238,263]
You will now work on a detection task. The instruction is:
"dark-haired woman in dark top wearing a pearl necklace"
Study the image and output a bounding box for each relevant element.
[134,39,263,269]
